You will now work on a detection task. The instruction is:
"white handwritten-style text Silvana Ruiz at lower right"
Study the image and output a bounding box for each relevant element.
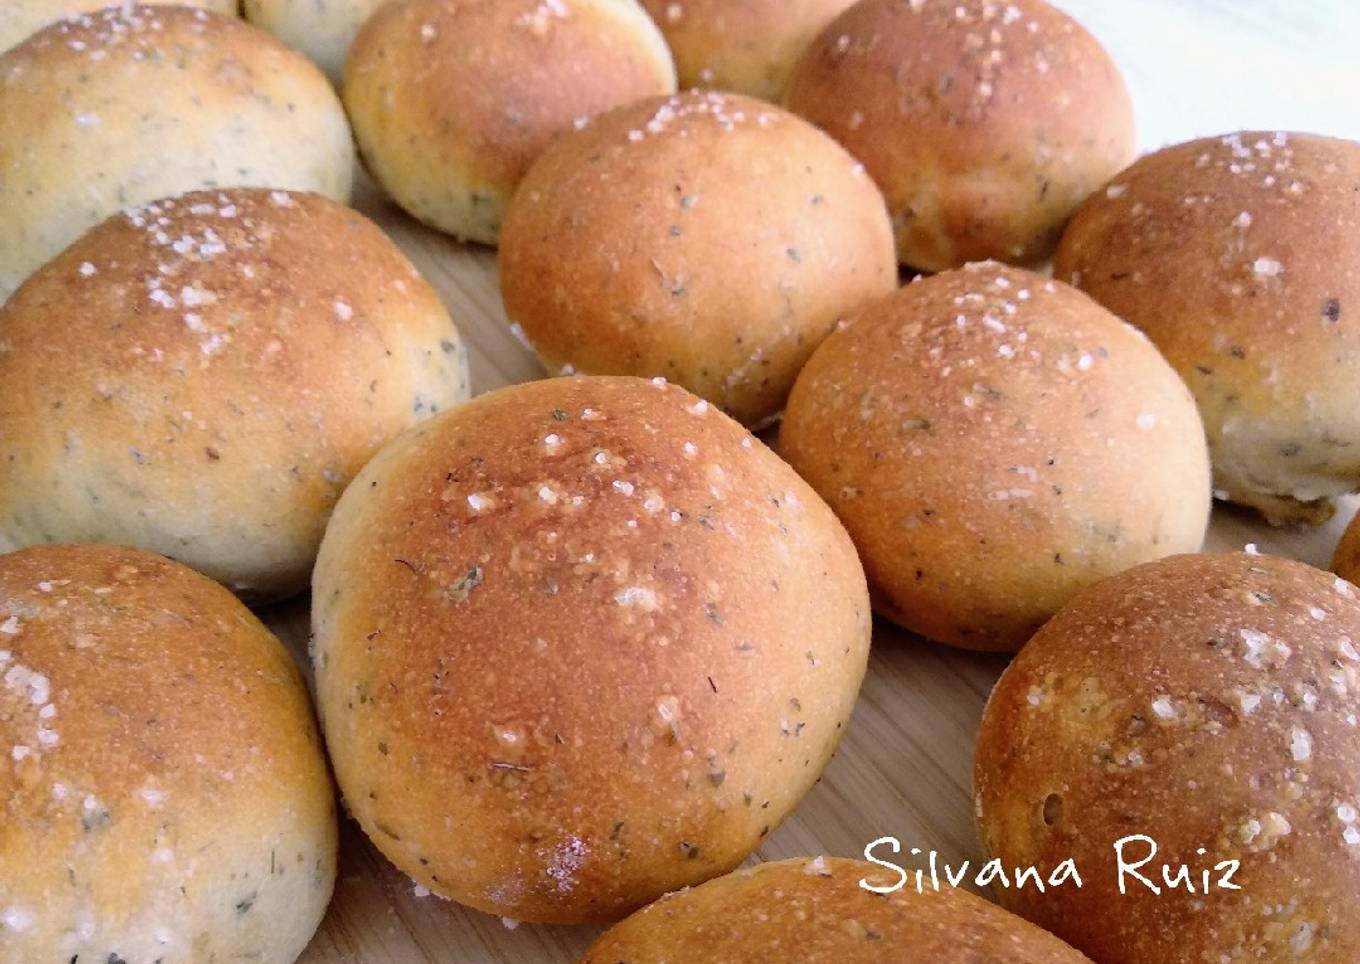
[860,833,1242,895]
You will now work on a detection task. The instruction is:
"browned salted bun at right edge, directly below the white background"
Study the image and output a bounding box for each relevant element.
[1057,132,1360,525]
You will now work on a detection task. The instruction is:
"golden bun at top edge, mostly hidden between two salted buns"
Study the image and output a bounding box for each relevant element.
[642,0,854,102]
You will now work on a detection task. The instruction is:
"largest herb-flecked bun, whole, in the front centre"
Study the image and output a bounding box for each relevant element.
[313,378,870,923]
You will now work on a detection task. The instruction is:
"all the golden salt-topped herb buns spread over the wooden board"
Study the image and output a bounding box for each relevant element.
[0,0,1360,964]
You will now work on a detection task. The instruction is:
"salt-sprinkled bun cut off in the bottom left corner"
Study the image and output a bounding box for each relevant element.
[0,545,336,964]
